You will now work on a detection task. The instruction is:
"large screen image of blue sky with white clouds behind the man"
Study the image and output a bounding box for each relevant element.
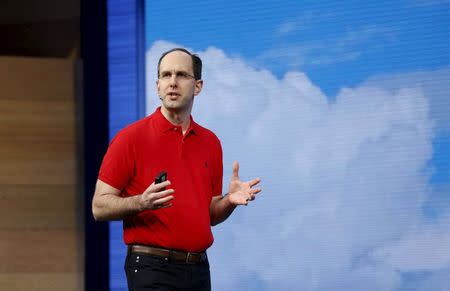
[146,0,450,291]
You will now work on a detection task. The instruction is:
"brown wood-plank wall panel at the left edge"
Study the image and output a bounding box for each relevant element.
[0,57,84,291]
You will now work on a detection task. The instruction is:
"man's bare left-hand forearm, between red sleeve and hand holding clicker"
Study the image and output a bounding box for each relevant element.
[92,194,140,221]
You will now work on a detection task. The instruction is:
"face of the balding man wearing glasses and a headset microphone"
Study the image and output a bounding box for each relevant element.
[156,51,203,111]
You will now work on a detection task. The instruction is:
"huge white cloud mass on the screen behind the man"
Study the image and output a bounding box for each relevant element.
[147,41,450,291]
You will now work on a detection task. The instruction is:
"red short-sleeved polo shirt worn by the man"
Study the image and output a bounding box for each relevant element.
[99,108,223,252]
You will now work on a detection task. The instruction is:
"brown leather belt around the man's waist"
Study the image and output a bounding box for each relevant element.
[128,245,207,264]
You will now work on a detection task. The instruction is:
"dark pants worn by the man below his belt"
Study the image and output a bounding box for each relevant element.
[125,253,211,291]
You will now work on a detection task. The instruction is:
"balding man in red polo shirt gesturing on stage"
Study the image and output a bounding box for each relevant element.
[92,48,261,291]
